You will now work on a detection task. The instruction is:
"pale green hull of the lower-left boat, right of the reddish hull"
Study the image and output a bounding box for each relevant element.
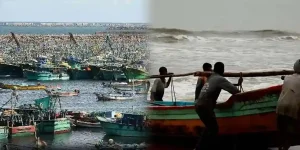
[37,118,71,134]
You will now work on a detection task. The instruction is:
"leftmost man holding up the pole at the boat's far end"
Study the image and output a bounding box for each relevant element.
[150,67,173,101]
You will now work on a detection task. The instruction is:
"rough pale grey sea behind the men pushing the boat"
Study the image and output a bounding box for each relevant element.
[148,28,300,149]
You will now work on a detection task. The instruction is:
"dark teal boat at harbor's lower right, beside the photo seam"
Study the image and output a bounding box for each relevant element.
[100,113,150,137]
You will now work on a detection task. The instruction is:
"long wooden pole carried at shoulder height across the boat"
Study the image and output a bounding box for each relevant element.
[148,70,295,78]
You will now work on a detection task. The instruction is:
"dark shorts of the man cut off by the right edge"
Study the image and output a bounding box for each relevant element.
[277,115,300,134]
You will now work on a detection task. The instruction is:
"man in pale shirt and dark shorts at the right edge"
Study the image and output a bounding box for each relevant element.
[276,59,300,150]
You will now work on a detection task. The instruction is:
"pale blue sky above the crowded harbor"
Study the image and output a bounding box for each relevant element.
[0,0,149,23]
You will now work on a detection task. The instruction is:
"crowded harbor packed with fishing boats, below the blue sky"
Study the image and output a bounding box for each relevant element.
[0,25,149,149]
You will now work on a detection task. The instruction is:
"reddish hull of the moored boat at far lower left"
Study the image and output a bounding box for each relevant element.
[8,125,36,137]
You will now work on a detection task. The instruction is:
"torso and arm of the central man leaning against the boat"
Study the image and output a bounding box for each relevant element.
[196,73,239,109]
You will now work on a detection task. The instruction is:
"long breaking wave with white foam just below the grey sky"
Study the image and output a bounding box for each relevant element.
[150,28,300,43]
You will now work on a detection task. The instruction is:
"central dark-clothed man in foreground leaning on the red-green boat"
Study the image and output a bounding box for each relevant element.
[195,62,240,150]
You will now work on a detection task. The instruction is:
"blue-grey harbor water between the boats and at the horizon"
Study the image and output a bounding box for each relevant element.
[0,26,147,150]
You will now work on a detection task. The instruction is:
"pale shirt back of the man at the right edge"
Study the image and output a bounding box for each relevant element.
[276,74,300,119]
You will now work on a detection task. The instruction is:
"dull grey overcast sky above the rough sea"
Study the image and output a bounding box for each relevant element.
[150,0,300,32]
